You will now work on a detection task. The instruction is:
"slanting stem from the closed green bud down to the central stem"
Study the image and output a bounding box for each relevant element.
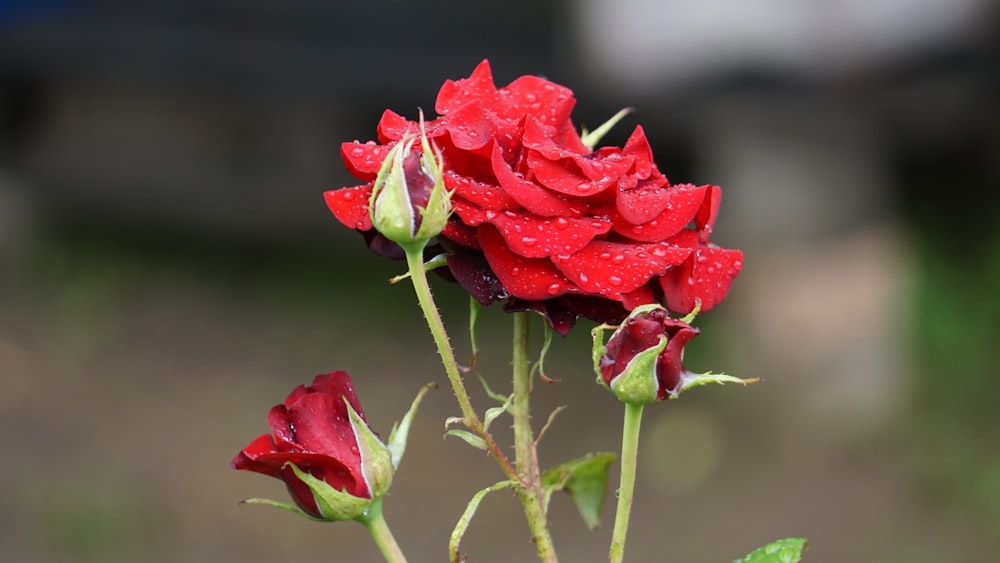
[404,247,518,479]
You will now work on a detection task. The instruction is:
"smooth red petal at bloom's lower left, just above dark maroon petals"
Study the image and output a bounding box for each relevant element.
[479,223,577,301]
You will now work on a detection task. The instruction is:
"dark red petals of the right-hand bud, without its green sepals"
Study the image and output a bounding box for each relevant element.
[598,308,699,401]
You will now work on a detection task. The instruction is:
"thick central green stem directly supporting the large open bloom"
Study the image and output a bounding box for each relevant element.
[510,313,558,562]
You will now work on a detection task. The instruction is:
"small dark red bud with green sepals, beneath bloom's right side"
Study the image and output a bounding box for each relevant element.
[593,304,757,405]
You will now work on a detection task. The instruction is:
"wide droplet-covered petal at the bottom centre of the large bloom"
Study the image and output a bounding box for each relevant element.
[552,240,691,296]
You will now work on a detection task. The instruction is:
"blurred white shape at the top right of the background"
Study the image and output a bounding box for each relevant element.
[577,0,988,89]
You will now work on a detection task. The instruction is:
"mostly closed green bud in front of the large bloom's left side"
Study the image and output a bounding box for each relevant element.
[369,124,451,247]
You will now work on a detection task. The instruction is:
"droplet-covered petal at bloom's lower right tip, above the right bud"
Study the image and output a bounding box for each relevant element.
[660,246,743,315]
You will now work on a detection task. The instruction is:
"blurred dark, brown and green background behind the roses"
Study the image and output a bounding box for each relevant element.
[0,0,1000,563]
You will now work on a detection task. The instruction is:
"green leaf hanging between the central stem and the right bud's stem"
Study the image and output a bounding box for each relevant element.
[542,452,615,530]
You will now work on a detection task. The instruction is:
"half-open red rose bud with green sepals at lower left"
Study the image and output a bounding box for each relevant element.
[232,371,426,521]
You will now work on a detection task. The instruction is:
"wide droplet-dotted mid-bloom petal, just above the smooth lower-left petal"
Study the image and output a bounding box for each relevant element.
[484,211,611,258]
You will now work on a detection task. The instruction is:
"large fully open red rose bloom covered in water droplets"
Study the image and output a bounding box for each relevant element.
[325,61,743,334]
